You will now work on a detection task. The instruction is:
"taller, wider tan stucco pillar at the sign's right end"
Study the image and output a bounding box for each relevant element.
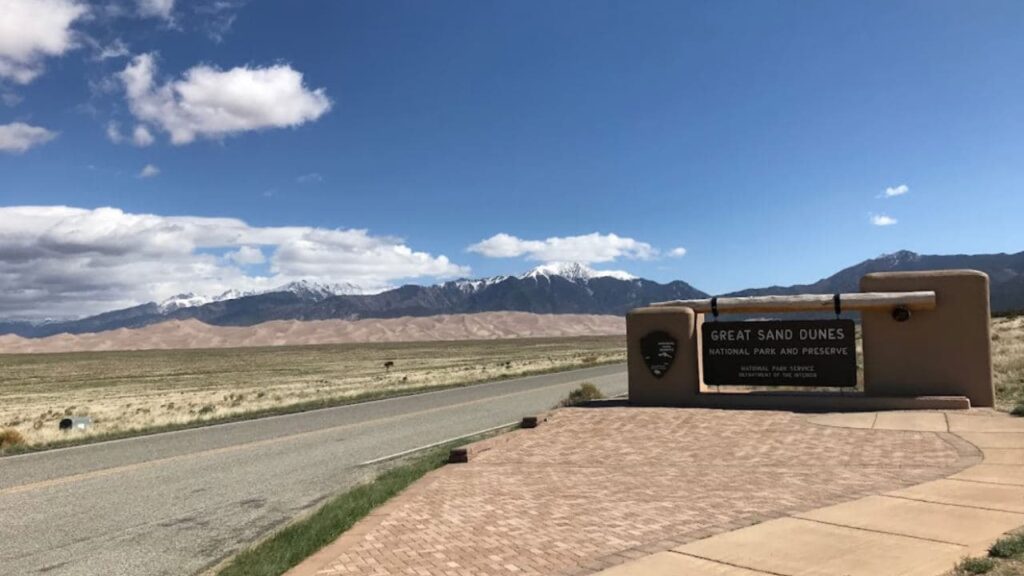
[860,270,994,406]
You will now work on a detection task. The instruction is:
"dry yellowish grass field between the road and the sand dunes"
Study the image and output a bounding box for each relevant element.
[0,336,626,445]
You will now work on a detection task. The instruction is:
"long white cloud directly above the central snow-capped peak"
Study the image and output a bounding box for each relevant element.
[467,233,657,263]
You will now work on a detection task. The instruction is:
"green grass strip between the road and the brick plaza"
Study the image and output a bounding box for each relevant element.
[217,446,451,576]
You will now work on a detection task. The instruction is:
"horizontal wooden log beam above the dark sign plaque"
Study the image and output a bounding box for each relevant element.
[650,290,935,314]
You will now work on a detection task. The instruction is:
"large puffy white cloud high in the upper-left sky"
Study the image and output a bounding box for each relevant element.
[120,54,331,145]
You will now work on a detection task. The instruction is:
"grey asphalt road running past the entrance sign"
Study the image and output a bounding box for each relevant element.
[0,365,626,576]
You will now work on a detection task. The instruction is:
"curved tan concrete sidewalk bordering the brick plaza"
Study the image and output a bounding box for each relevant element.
[600,412,1024,576]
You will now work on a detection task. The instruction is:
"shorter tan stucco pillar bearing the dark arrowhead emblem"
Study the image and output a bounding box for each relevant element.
[626,306,699,406]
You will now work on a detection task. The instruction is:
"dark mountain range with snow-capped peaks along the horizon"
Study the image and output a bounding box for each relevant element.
[0,250,1024,338]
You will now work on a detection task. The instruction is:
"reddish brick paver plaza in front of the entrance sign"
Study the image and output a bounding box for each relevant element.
[305,407,978,576]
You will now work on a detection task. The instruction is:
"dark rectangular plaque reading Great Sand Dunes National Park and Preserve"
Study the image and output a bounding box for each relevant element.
[700,320,857,387]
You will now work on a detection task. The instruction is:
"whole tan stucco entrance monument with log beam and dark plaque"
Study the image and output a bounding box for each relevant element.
[626,270,994,410]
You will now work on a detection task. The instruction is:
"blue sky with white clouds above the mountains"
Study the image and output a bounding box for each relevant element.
[0,0,1024,314]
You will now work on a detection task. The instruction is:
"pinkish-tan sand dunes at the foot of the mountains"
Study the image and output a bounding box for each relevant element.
[0,312,626,354]
